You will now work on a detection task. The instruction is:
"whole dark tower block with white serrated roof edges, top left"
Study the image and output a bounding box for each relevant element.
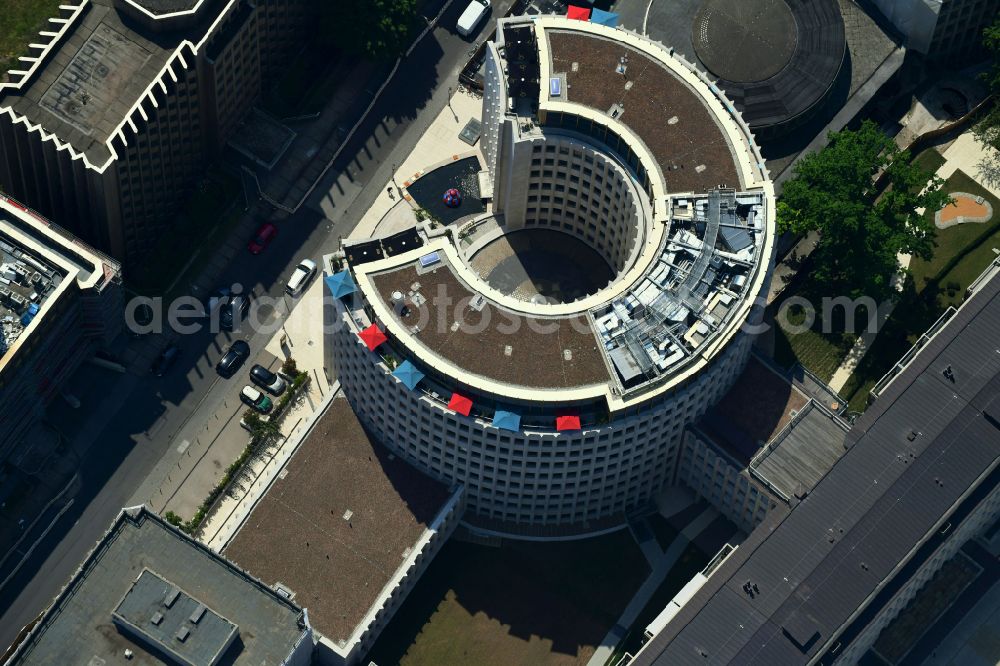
[0,0,313,261]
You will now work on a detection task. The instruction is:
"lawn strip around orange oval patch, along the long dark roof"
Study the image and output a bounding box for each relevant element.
[841,171,1000,411]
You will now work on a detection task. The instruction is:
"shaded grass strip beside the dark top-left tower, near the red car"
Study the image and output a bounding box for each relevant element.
[129,169,242,296]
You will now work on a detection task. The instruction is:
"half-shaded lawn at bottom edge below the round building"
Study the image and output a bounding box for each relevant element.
[368,530,649,666]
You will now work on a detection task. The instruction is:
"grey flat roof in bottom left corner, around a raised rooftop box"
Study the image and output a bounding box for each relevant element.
[8,507,309,666]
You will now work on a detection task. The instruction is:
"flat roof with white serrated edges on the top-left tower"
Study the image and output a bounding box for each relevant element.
[0,0,237,171]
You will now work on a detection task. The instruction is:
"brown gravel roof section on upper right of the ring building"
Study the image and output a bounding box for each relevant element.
[542,29,749,192]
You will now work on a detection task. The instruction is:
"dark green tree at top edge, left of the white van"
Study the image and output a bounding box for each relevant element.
[321,0,417,60]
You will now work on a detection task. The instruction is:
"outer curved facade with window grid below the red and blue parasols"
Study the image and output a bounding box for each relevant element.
[330,313,753,526]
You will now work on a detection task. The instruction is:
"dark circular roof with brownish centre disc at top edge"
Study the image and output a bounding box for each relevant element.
[691,0,847,128]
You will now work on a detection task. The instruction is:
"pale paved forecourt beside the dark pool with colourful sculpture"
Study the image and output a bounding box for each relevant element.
[346,90,483,240]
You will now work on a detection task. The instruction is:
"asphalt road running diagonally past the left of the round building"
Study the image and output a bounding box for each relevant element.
[0,0,510,646]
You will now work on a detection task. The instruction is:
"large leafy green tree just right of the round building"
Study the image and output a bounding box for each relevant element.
[778,121,948,301]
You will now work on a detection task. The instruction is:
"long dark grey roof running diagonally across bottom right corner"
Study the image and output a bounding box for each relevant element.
[633,278,1000,666]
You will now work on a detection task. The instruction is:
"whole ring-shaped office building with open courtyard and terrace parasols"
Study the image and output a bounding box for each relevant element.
[327,17,774,537]
